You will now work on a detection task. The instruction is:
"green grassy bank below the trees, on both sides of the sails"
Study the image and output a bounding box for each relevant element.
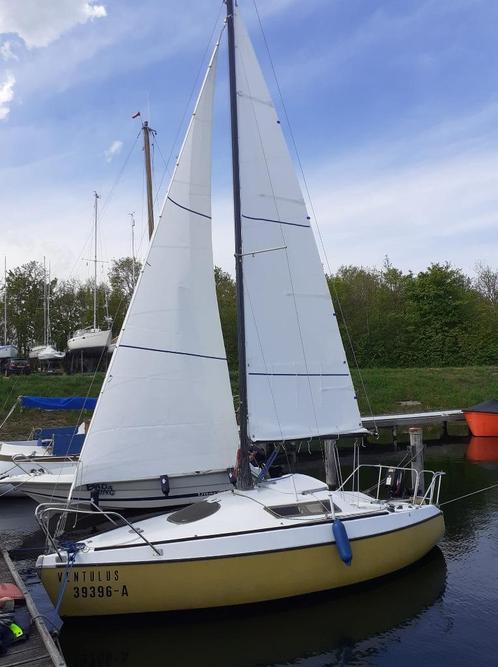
[0,366,498,439]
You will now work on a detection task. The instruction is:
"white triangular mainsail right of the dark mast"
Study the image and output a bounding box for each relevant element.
[235,13,362,441]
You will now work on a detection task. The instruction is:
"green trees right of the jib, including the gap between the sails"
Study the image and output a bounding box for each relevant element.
[220,258,498,368]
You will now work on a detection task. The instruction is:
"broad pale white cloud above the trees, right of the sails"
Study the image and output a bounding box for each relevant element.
[310,141,498,273]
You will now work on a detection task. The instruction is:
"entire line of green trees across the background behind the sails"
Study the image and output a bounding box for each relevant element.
[2,257,498,369]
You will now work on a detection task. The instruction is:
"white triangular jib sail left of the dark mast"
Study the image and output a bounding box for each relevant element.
[74,44,238,486]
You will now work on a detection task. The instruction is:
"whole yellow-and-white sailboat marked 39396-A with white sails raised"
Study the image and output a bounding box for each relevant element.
[37,0,444,616]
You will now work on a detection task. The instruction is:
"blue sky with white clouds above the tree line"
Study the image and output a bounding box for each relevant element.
[0,0,498,279]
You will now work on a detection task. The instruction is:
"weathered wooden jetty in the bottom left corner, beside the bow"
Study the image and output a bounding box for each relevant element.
[0,549,66,667]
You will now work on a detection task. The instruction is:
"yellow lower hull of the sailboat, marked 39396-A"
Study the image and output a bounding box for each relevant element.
[39,514,444,616]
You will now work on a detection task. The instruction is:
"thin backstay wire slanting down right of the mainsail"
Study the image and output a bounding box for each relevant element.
[253,0,379,436]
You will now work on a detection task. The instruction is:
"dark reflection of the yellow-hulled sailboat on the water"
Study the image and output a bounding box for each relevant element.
[62,548,446,667]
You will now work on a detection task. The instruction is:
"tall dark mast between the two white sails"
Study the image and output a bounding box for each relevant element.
[226,0,253,489]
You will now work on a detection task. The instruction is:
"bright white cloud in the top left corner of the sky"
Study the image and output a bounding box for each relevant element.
[0,0,107,48]
